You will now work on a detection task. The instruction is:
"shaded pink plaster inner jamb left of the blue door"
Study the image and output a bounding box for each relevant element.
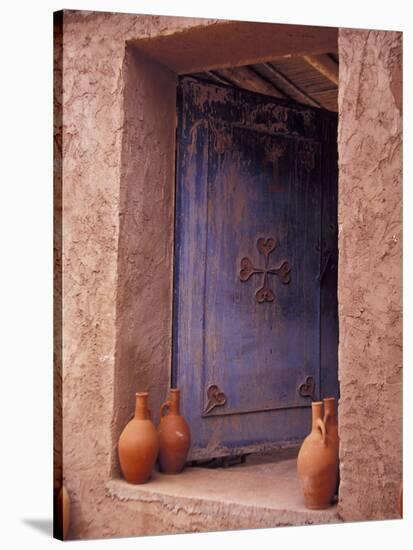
[113,46,177,471]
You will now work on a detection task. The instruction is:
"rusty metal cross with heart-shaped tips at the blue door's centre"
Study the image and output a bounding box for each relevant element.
[239,237,291,304]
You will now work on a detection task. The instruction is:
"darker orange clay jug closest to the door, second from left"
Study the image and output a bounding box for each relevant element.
[158,389,191,474]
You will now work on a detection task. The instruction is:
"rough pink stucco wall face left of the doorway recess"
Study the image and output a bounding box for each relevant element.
[62,11,219,538]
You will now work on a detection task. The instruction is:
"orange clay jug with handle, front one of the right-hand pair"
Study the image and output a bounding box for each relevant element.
[297,401,338,510]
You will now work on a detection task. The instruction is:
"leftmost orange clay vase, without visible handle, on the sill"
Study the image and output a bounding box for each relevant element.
[118,392,159,484]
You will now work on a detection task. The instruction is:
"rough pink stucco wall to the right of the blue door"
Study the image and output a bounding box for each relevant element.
[338,29,402,521]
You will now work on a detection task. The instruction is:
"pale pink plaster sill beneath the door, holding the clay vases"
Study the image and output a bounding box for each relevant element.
[107,449,341,532]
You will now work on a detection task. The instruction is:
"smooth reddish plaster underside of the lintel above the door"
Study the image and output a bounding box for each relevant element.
[129,21,337,74]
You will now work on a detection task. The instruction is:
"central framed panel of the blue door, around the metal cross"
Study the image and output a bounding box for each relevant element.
[203,128,321,414]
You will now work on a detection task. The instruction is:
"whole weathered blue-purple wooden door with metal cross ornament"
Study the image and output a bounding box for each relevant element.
[173,78,338,459]
